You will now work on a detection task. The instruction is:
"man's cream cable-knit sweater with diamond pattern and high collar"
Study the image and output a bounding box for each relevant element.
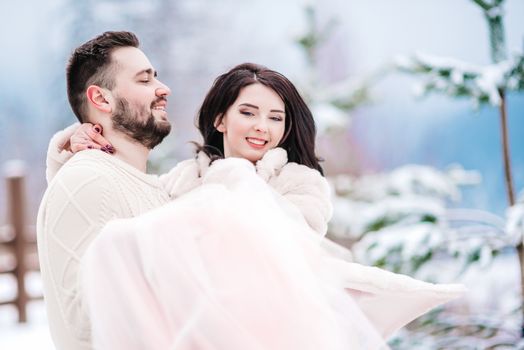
[37,150,169,350]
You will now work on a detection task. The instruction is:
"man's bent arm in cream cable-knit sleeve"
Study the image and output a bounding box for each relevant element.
[38,161,124,340]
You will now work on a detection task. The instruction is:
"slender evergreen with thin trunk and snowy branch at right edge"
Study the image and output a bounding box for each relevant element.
[397,0,524,336]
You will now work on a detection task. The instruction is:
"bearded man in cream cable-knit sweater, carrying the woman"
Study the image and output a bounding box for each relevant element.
[37,32,171,350]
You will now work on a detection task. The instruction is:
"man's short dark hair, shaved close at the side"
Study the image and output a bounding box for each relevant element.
[66,32,140,123]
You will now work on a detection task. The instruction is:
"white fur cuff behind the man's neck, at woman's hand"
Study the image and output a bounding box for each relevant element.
[45,123,80,184]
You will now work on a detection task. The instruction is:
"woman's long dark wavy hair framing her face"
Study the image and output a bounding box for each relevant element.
[197,63,322,173]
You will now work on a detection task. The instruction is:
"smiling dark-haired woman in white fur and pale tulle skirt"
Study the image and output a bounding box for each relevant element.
[50,64,463,349]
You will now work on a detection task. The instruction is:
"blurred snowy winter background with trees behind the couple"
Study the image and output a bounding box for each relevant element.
[0,0,524,349]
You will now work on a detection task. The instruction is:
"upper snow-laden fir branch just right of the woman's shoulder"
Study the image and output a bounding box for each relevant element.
[330,164,474,239]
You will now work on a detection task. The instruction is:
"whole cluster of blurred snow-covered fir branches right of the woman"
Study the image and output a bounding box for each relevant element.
[329,165,524,275]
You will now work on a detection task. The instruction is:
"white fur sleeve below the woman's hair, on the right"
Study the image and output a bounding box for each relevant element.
[268,163,333,236]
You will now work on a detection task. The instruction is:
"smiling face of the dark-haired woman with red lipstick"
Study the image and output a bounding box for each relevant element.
[216,83,286,162]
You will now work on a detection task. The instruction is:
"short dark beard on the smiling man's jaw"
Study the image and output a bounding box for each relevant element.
[112,98,171,149]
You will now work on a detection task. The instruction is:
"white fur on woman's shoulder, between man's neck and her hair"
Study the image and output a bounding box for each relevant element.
[160,152,210,199]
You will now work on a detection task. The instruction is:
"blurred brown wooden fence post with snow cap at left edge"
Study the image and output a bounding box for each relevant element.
[0,161,42,323]
